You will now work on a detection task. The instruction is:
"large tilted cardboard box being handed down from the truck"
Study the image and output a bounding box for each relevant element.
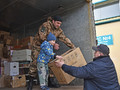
[48,48,87,84]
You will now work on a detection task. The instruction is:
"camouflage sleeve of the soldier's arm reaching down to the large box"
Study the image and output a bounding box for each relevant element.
[58,31,75,49]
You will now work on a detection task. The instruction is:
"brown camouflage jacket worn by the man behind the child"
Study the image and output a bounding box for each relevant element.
[32,17,75,59]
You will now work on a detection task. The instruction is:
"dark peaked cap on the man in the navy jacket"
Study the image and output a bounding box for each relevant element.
[92,44,110,55]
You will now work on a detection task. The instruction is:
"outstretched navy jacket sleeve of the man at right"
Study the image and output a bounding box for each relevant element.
[62,64,95,78]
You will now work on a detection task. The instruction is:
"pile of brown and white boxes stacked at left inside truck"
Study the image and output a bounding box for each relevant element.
[0,31,33,88]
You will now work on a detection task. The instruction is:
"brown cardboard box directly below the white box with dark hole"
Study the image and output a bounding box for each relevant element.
[12,75,26,88]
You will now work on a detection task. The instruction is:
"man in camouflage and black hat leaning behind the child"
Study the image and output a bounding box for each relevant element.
[29,16,75,90]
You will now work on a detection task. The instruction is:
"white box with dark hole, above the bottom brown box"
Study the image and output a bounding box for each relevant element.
[4,62,19,76]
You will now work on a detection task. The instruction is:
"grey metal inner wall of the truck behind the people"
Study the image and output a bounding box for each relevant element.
[11,1,96,85]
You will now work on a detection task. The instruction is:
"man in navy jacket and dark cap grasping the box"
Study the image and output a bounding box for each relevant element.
[56,44,120,90]
